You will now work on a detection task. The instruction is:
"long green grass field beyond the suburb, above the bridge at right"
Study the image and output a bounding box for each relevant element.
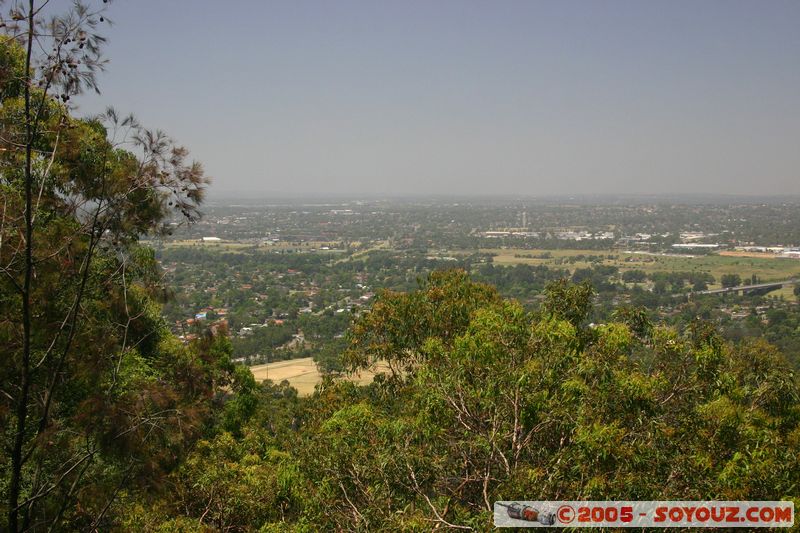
[480,249,800,281]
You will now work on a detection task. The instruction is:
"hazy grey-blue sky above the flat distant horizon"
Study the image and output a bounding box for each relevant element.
[79,0,800,196]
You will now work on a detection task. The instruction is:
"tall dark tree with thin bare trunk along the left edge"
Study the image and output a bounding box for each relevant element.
[0,0,207,531]
